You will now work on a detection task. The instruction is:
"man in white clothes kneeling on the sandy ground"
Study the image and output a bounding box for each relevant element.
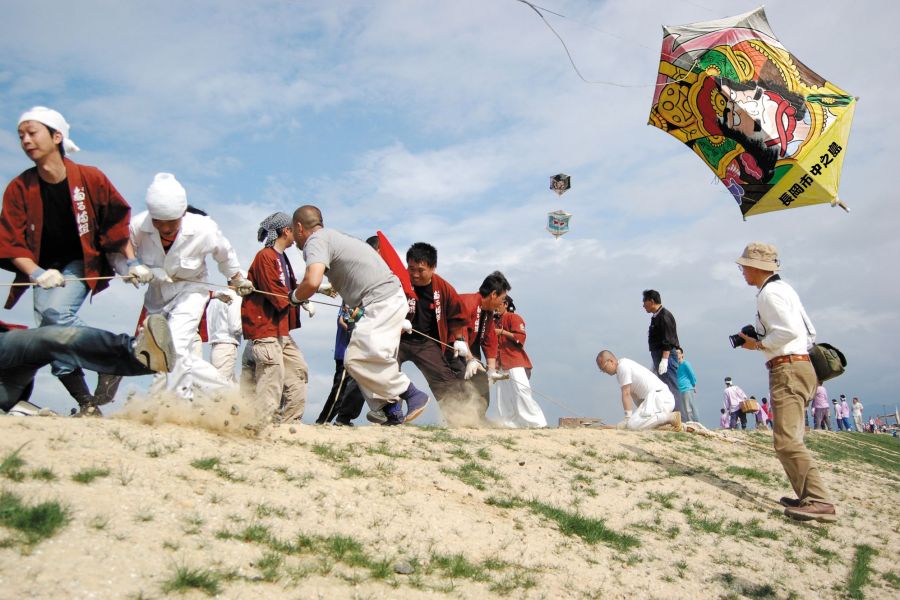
[597,350,681,431]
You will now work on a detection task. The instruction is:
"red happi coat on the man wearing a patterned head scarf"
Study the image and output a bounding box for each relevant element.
[241,247,300,340]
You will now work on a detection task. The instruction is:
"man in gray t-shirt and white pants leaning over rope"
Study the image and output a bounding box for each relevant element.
[290,205,428,425]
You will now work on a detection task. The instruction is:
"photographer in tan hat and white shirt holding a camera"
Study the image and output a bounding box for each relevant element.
[737,242,837,522]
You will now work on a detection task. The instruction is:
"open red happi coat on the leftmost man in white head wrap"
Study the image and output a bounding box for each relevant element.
[0,158,131,308]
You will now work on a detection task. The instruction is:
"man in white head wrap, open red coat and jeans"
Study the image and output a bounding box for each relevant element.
[0,106,150,414]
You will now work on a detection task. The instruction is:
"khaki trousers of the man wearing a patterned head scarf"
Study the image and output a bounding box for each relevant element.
[250,336,309,422]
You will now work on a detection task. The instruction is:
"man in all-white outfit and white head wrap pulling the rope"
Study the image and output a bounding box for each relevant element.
[116,173,253,400]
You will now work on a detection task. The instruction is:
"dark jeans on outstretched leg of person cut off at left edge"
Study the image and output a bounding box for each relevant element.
[0,325,153,410]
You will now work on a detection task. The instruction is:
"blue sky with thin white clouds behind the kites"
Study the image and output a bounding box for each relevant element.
[0,0,900,425]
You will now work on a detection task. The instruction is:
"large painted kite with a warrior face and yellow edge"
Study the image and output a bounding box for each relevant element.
[649,7,856,218]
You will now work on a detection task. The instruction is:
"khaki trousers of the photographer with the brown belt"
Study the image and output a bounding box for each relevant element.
[769,362,830,503]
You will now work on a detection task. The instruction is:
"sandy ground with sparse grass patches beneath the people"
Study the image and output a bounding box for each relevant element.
[0,402,900,599]
